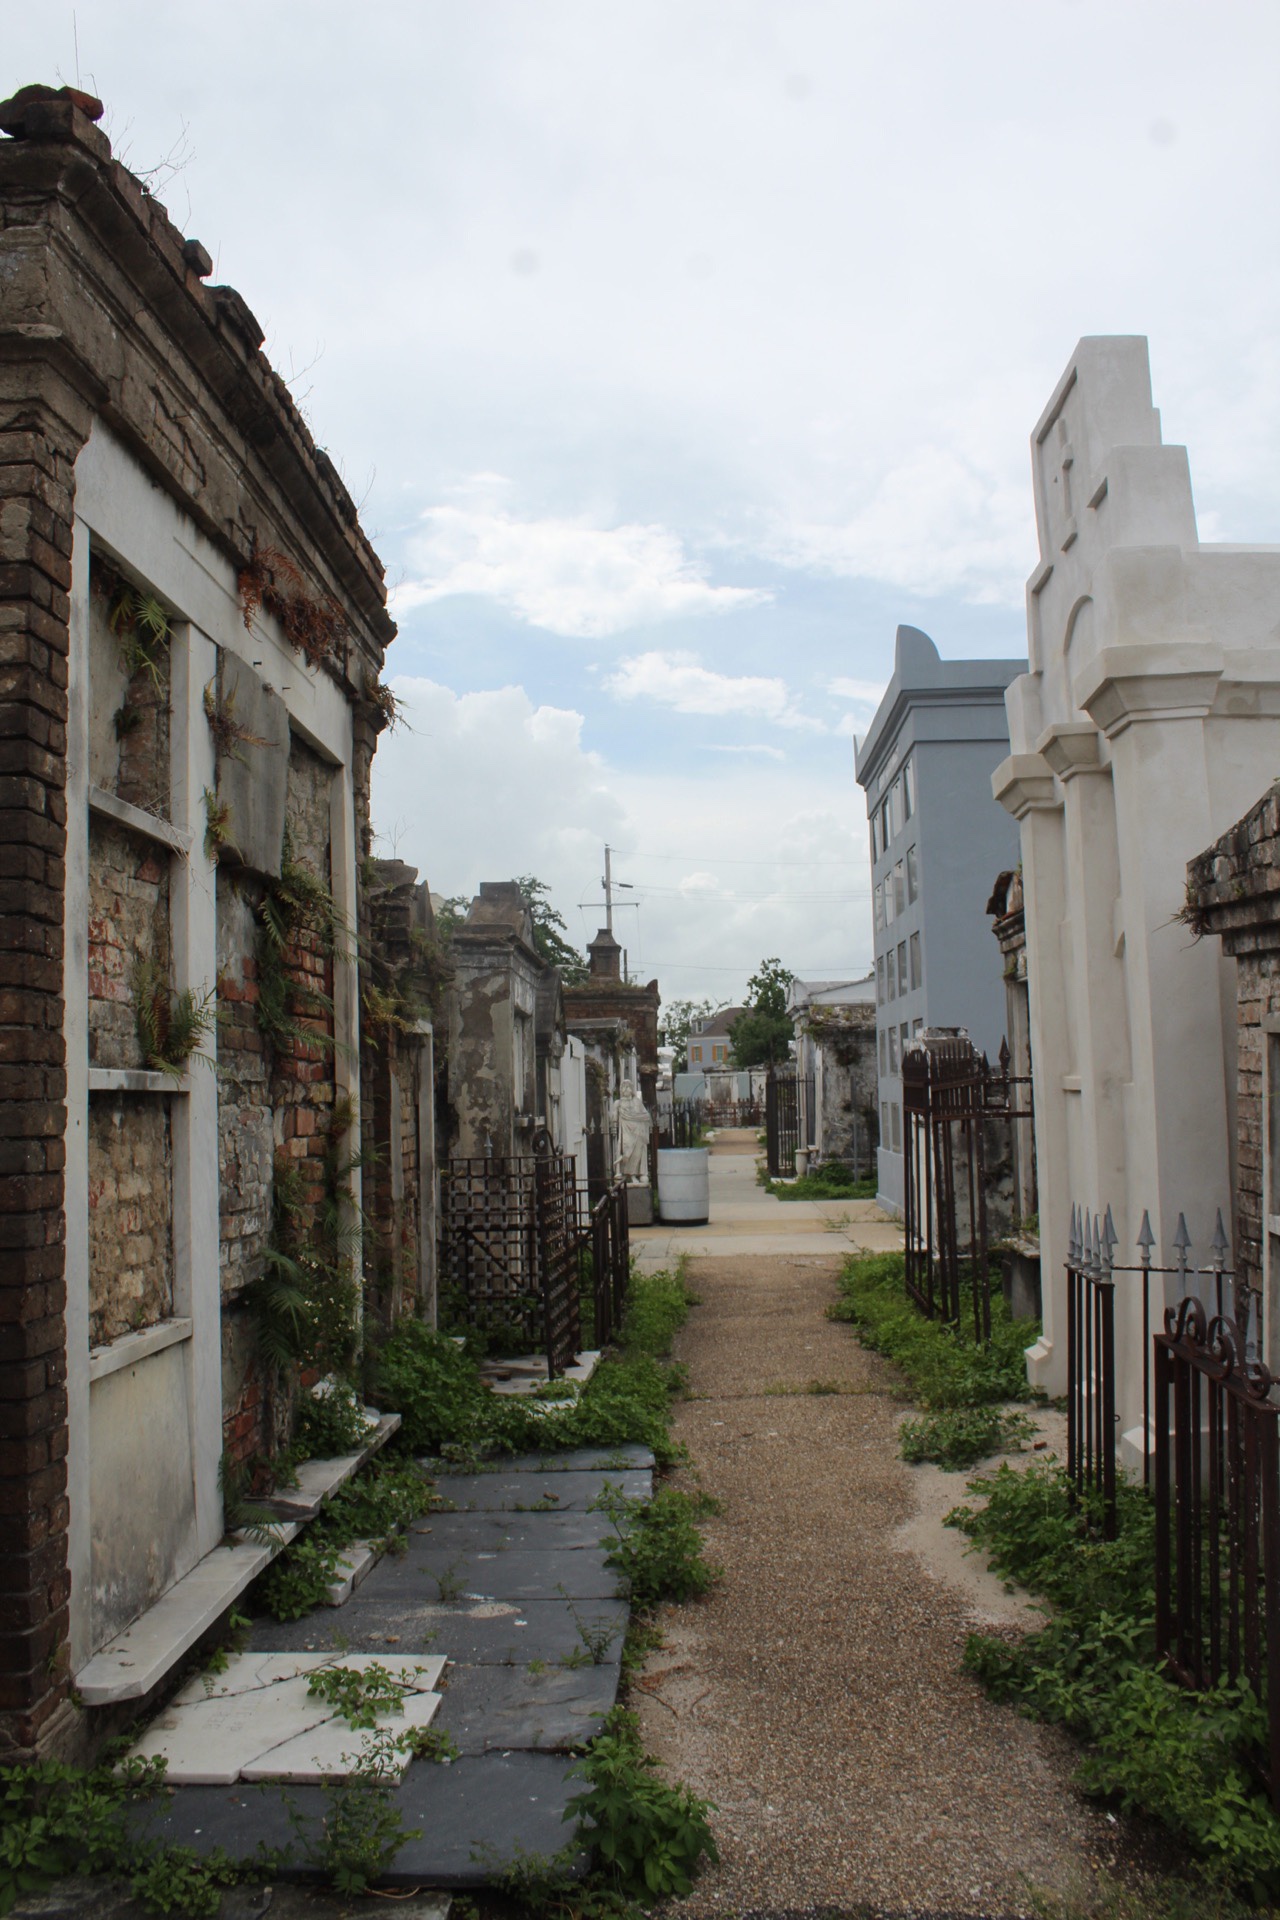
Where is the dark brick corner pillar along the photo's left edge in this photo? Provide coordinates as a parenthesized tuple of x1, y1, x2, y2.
(0, 318, 88, 1749)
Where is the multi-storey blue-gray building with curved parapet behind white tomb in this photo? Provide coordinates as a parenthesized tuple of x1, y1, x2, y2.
(856, 626, 1027, 1213)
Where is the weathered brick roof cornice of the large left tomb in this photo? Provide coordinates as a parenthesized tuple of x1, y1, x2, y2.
(0, 86, 395, 680)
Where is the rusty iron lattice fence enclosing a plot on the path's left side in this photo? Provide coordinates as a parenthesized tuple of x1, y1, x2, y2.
(441, 1154, 581, 1379)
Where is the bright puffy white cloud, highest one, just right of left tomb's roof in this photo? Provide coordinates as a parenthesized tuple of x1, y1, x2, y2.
(391, 474, 771, 639)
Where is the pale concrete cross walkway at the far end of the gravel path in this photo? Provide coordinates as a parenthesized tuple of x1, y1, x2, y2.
(631, 1127, 902, 1273)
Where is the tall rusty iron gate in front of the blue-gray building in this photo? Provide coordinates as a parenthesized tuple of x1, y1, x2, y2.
(902, 1029, 1031, 1340)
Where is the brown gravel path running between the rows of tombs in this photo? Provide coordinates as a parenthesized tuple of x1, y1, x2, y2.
(633, 1256, 1121, 1914)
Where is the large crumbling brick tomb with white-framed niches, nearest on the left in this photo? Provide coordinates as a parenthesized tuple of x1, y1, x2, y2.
(0, 88, 416, 1749)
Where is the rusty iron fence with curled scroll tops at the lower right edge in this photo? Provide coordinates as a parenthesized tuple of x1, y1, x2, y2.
(1153, 1298, 1280, 1811)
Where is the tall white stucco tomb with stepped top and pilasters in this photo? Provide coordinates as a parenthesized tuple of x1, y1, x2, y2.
(992, 338, 1280, 1457)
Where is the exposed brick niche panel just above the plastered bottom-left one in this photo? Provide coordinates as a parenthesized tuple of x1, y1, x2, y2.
(88, 1094, 173, 1346)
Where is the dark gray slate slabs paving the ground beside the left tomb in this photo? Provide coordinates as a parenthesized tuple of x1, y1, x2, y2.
(132, 1448, 652, 1887)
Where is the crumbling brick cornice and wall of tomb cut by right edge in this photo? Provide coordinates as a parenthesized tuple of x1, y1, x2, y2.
(1184, 783, 1280, 1286)
